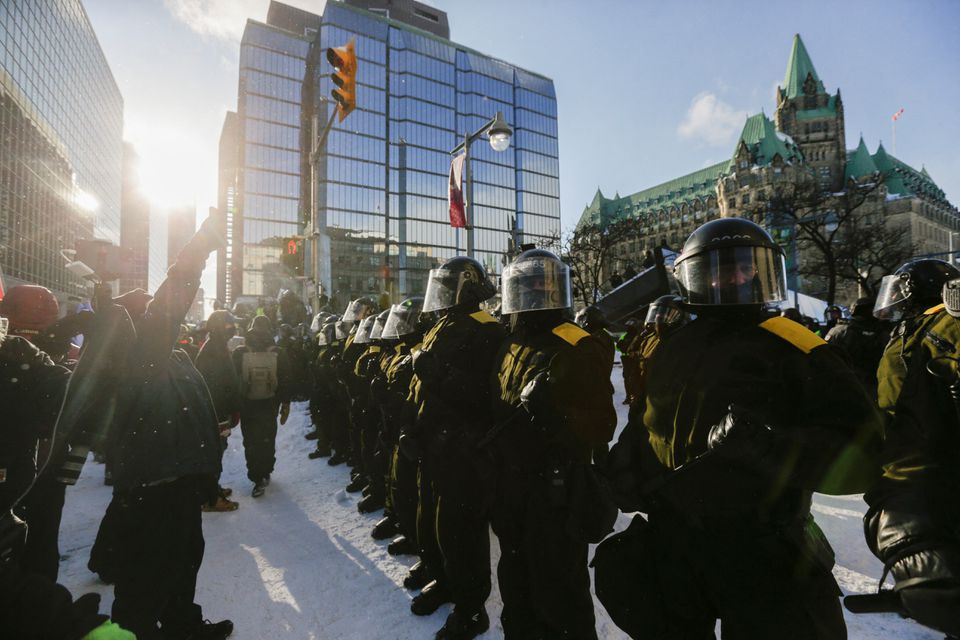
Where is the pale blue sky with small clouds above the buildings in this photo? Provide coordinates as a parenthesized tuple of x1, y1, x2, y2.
(84, 0, 960, 235)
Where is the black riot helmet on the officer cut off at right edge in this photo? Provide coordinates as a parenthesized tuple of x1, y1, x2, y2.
(873, 258, 960, 321)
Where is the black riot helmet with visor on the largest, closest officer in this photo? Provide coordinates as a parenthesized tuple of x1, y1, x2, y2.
(674, 218, 787, 308)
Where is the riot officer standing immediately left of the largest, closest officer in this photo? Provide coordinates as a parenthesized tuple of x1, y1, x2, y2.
(487, 249, 617, 640)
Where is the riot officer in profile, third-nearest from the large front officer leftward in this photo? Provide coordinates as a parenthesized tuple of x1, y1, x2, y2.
(410, 256, 503, 640)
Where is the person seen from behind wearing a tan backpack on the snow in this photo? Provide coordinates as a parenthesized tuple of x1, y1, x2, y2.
(233, 316, 291, 498)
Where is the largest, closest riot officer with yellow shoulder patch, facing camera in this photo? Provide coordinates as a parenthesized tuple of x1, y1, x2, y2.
(594, 218, 881, 640)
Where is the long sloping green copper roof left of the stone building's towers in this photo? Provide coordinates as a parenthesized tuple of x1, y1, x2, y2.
(577, 160, 729, 227)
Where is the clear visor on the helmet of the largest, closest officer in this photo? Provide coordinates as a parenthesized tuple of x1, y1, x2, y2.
(675, 247, 787, 305)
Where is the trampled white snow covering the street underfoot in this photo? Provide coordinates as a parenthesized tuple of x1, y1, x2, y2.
(60, 367, 943, 640)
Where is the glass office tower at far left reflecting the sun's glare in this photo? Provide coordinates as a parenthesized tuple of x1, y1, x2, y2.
(0, 0, 123, 297)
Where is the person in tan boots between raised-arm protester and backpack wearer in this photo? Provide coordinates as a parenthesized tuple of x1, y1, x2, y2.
(196, 309, 241, 511)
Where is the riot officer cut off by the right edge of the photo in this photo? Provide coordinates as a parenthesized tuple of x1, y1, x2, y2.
(864, 259, 960, 637)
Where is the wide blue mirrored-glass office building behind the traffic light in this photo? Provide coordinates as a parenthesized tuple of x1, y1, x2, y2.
(234, 0, 560, 305)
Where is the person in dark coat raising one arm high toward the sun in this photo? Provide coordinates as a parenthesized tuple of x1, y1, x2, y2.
(91, 218, 233, 640)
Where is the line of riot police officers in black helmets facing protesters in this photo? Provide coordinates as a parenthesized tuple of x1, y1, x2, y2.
(308, 218, 960, 640)
